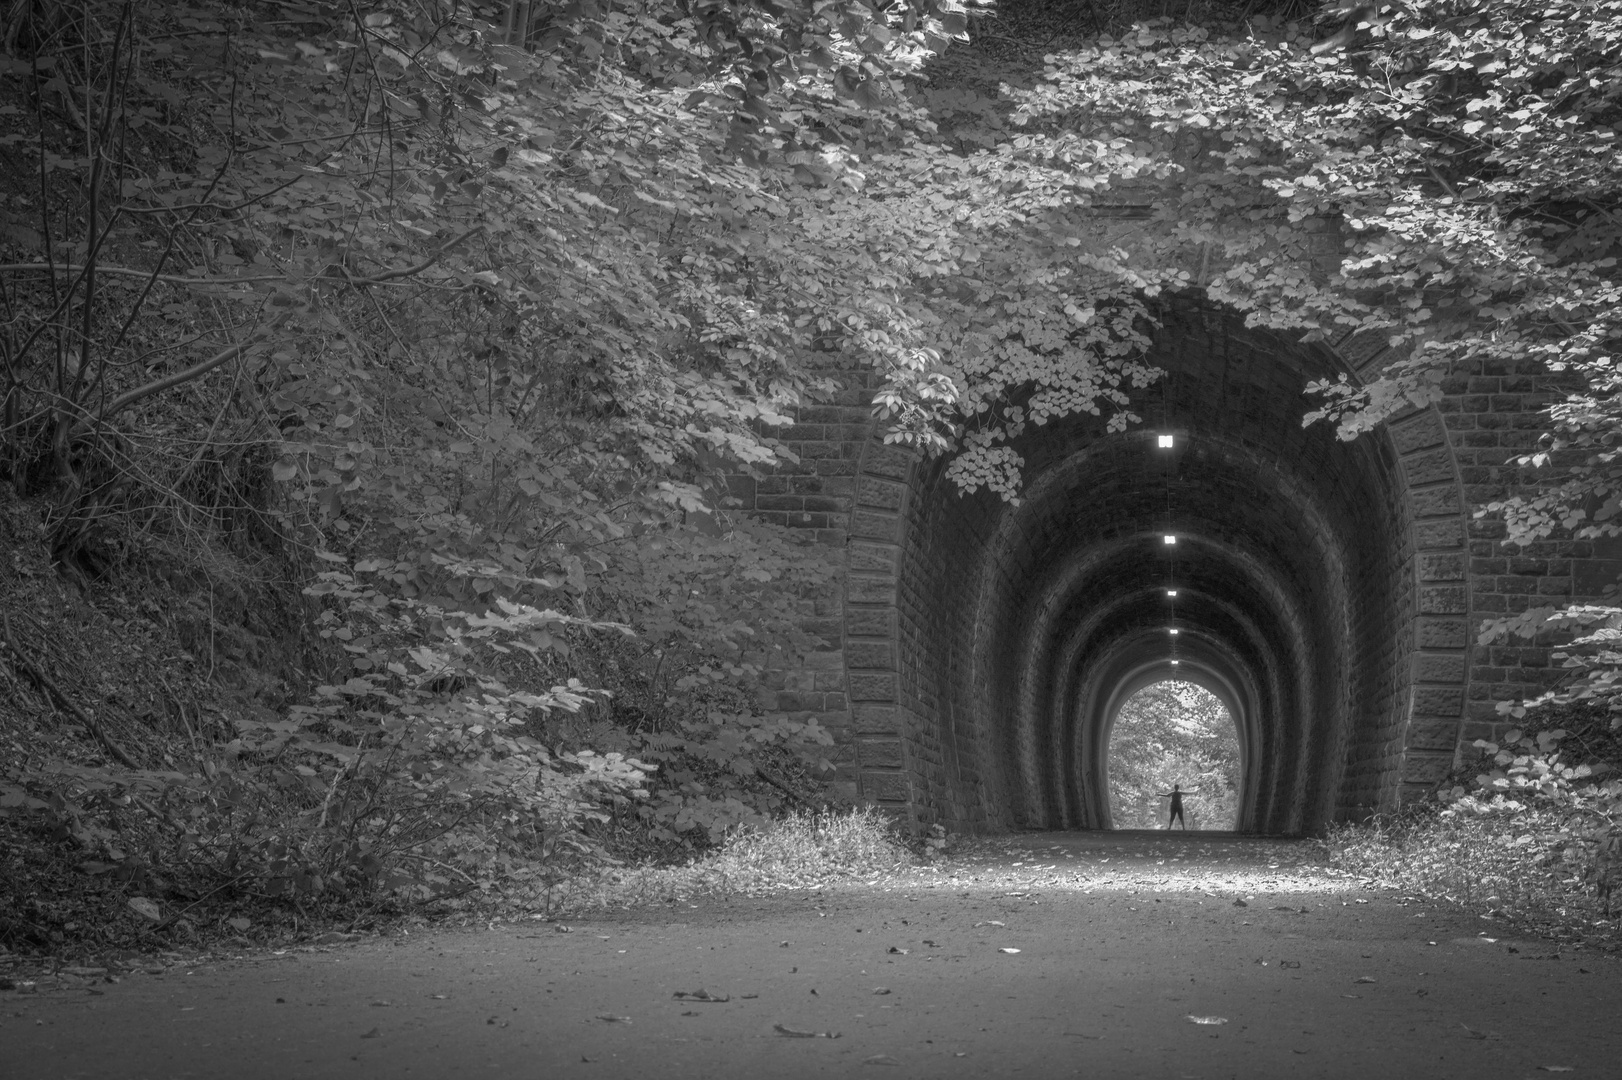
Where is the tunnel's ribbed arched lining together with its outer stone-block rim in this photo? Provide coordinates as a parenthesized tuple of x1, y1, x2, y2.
(830, 305, 1471, 832)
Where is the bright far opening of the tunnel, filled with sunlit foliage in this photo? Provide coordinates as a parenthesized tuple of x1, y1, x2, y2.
(1106, 679, 1242, 832)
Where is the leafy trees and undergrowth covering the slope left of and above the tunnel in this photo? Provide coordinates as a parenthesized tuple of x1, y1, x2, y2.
(0, 0, 1622, 949)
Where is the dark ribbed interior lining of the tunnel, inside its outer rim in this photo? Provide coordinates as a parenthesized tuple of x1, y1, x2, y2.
(897, 303, 1414, 835)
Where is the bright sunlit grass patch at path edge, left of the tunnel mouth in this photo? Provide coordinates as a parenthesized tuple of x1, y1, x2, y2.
(551, 808, 916, 911)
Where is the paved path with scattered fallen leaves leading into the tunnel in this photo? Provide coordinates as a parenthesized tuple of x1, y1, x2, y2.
(0, 834, 1622, 1080)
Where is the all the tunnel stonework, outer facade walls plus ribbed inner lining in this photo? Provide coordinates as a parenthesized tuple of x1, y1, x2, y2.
(732, 295, 1622, 834)
